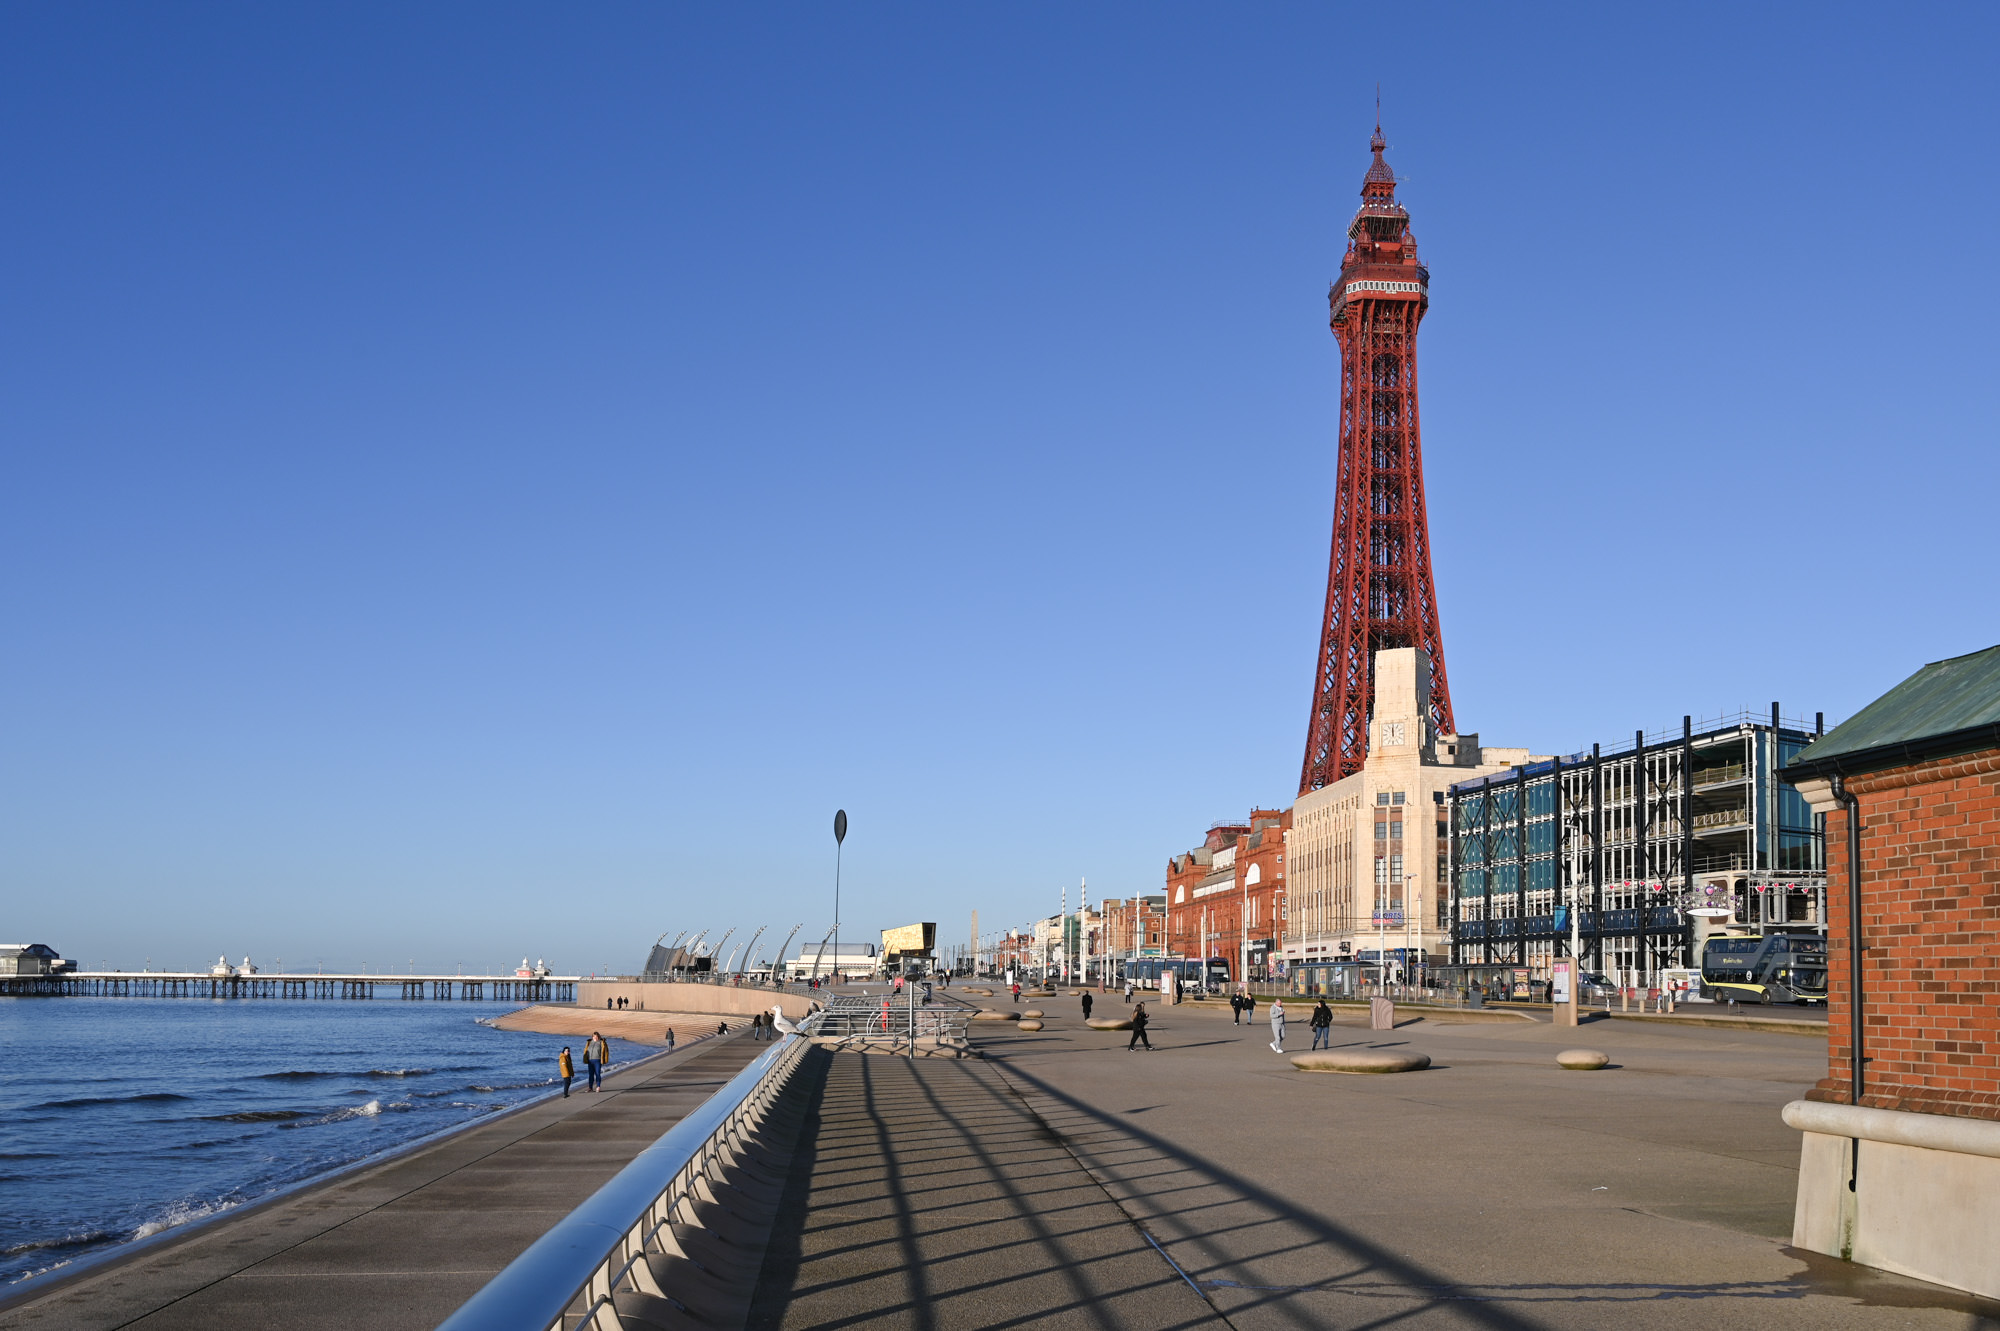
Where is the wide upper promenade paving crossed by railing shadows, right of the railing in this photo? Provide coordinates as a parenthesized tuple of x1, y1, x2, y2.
(752, 995, 2000, 1331)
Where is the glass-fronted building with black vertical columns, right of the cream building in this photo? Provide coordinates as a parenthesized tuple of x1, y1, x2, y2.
(1446, 707, 1826, 985)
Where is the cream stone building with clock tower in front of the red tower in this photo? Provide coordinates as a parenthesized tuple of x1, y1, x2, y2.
(1284, 648, 1540, 969)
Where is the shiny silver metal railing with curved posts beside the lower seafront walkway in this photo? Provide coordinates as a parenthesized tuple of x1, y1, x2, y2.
(438, 1013, 824, 1331)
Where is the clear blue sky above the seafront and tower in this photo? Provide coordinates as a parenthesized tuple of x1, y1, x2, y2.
(0, 4, 2000, 969)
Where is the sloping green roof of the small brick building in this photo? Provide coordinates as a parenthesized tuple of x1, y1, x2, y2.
(1784, 646, 2000, 777)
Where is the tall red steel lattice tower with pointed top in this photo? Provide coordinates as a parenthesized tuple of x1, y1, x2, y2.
(1298, 124, 1454, 793)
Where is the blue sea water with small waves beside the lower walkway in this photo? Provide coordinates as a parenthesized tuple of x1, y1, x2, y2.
(0, 997, 654, 1283)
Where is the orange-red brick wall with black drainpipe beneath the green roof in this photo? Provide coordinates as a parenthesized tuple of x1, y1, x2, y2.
(1810, 749, 2000, 1119)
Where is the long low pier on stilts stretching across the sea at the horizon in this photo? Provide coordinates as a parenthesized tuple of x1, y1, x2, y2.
(0, 971, 582, 1003)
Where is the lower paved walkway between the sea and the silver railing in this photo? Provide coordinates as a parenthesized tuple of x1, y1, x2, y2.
(0, 1035, 770, 1331)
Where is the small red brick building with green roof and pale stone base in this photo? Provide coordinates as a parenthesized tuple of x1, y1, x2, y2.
(1784, 648, 2000, 1297)
